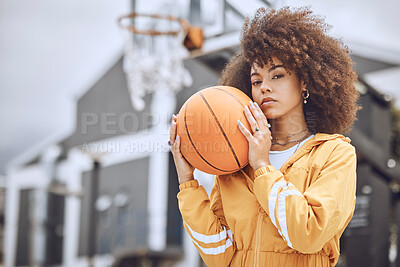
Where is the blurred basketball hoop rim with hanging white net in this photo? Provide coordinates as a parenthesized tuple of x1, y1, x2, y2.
(118, 13, 192, 111)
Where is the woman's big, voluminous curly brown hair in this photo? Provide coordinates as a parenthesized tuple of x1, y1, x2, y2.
(219, 6, 360, 133)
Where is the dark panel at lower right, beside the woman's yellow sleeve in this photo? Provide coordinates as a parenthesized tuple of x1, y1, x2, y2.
(340, 164, 391, 267)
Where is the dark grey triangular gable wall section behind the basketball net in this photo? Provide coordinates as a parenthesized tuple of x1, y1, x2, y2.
(62, 60, 152, 150)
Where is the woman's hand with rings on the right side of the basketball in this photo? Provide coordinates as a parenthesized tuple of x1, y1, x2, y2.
(238, 101, 271, 170)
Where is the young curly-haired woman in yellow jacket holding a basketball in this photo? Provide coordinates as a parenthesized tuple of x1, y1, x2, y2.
(170, 7, 359, 267)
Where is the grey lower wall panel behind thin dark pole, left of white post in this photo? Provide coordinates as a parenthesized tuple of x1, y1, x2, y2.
(79, 158, 149, 255)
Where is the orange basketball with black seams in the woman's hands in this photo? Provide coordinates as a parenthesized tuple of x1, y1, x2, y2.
(177, 86, 250, 175)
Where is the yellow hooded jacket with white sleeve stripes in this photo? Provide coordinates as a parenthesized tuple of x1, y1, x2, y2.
(178, 133, 357, 267)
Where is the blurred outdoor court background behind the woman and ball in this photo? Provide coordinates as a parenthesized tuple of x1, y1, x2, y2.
(0, 0, 400, 267)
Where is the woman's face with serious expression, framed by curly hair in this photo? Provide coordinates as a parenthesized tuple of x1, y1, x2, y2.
(250, 57, 305, 119)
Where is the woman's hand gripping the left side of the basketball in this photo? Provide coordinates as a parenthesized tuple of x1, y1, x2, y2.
(169, 115, 194, 184)
